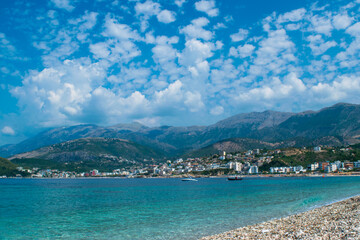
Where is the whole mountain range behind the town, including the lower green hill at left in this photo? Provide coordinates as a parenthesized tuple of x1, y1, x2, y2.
(0, 103, 360, 164)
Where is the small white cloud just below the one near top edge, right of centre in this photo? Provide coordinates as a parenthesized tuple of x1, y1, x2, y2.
(180, 17, 213, 41)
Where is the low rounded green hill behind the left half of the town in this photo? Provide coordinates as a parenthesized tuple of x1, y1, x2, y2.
(10, 138, 163, 169)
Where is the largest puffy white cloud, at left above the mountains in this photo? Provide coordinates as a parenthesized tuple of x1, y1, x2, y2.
(11, 61, 105, 126)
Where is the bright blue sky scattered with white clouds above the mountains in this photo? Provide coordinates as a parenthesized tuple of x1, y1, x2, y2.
(0, 0, 360, 145)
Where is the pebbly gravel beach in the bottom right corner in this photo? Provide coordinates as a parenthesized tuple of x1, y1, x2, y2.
(201, 196, 360, 240)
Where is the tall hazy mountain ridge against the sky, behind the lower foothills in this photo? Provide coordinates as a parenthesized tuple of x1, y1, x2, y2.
(0, 103, 360, 157)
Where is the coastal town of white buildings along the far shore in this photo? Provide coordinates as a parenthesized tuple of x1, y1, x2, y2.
(5, 146, 360, 178)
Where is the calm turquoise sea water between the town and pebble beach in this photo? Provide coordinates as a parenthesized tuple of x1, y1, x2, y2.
(0, 177, 360, 240)
